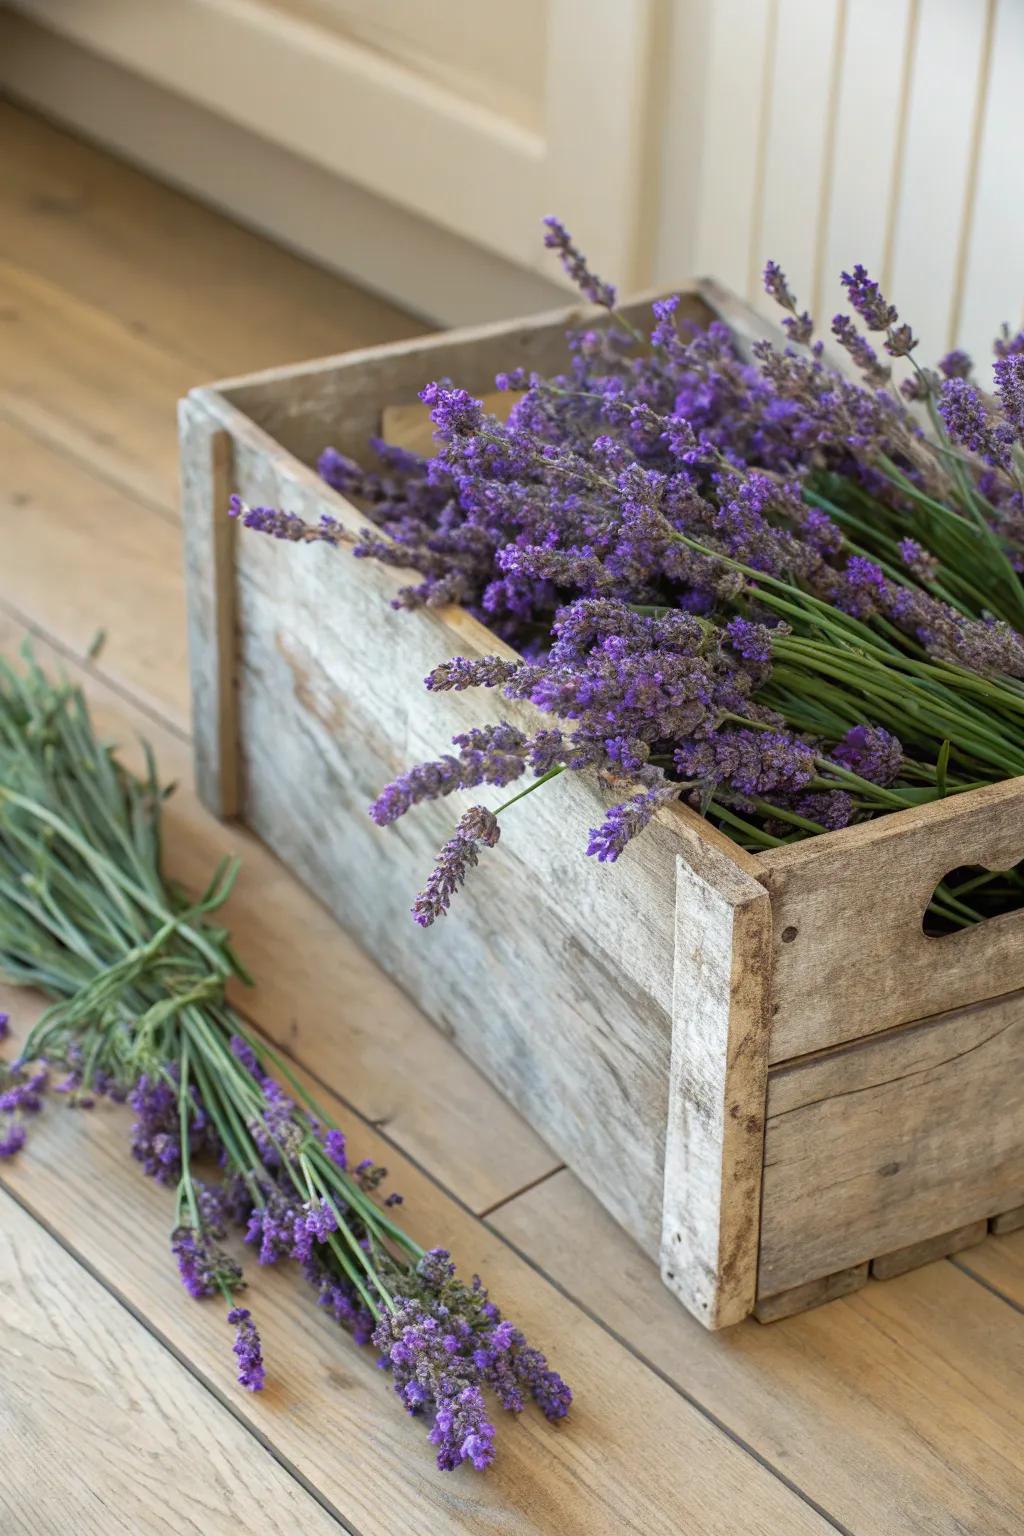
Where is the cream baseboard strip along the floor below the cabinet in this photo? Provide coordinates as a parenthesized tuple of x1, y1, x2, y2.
(0, 9, 565, 326)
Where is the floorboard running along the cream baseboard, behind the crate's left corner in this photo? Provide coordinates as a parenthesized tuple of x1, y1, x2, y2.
(0, 101, 422, 378)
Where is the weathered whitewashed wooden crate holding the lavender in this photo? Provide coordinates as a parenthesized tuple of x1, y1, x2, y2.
(181, 293, 1024, 1327)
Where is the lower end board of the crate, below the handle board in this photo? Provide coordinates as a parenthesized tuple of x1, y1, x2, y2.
(758, 992, 1024, 1295)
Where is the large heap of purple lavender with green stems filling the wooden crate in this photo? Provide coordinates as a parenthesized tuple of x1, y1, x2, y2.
(233, 220, 1024, 931)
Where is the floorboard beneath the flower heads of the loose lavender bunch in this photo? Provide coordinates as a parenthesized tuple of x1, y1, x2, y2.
(0, 1007, 831, 1536)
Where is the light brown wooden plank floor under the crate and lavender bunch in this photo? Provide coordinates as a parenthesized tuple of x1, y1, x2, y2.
(0, 104, 1024, 1536)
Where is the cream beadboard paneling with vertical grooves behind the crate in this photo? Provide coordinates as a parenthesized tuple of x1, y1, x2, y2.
(666, 0, 1024, 362)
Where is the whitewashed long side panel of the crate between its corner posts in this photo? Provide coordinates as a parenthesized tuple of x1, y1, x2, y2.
(225, 462, 680, 1252)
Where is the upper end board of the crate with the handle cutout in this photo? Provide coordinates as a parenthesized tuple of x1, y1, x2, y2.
(761, 779, 1024, 1062)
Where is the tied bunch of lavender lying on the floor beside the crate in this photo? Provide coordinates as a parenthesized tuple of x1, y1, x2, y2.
(0, 662, 571, 1470)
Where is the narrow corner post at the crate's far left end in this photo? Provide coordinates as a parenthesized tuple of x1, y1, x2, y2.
(178, 389, 239, 819)
